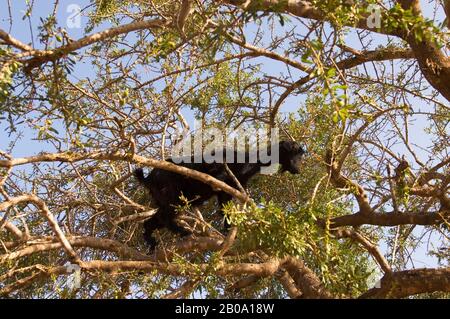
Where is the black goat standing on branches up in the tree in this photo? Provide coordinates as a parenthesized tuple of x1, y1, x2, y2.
(134, 141, 305, 249)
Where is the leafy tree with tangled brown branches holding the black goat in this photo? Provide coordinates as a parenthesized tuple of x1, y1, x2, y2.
(0, 0, 450, 298)
